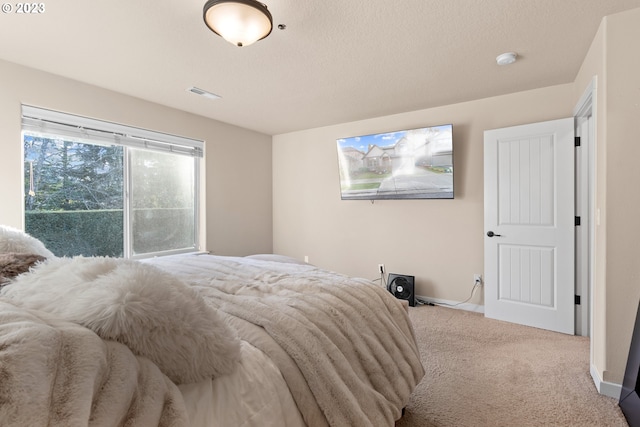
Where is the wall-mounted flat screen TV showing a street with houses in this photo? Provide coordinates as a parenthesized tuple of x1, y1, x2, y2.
(336, 124, 453, 200)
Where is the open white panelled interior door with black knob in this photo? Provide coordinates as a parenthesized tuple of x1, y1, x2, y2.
(484, 118, 575, 334)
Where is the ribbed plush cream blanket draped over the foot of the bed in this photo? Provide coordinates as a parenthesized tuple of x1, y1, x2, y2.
(148, 255, 424, 426)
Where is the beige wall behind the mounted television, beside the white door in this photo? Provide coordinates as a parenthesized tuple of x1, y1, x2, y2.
(273, 84, 575, 305)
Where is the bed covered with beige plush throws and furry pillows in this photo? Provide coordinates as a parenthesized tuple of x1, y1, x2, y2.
(0, 226, 424, 427)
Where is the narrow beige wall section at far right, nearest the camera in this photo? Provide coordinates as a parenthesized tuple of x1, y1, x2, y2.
(603, 9, 640, 383)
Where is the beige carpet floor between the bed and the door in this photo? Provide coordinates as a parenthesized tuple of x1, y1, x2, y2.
(396, 306, 627, 427)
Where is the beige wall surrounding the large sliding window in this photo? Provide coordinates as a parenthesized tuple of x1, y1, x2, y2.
(0, 61, 272, 255)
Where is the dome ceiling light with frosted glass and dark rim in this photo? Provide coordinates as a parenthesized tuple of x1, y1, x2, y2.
(202, 0, 273, 46)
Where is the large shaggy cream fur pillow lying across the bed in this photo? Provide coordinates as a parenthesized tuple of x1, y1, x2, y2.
(0, 257, 240, 384)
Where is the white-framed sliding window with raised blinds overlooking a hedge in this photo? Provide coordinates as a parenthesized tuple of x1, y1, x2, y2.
(22, 106, 203, 258)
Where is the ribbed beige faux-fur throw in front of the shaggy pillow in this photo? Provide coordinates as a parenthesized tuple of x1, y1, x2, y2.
(0, 300, 189, 427)
